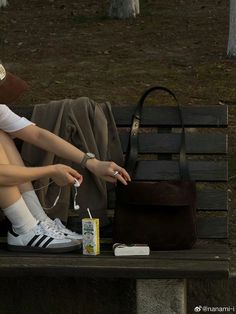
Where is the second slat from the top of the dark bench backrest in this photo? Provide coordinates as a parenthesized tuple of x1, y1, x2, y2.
(120, 133, 227, 154)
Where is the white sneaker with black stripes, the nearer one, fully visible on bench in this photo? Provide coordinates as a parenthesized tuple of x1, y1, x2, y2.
(7, 221, 81, 253)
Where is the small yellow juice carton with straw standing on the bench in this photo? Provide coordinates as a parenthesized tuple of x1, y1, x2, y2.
(82, 218, 100, 255)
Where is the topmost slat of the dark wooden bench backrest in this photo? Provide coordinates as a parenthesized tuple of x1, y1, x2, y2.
(112, 105, 228, 127)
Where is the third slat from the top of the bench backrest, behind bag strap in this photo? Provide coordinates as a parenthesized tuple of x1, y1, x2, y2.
(135, 160, 228, 182)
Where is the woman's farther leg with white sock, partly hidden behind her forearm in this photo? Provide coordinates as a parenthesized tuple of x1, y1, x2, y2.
(0, 131, 48, 221)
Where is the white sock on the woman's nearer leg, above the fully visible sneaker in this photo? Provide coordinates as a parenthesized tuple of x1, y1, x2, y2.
(3, 197, 37, 234)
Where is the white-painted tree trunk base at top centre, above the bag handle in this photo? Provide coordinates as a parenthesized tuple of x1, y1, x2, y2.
(109, 0, 139, 19)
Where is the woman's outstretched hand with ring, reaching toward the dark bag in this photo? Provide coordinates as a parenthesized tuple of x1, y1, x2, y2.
(86, 159, 131, 185)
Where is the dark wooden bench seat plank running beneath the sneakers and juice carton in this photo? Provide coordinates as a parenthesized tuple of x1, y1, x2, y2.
(0, 252, 229, 279)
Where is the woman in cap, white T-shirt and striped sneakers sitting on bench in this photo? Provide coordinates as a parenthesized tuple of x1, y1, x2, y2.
(0, 65, 130, 252)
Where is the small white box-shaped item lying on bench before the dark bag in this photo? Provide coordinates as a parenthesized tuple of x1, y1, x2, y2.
(113, 243, 150, 256)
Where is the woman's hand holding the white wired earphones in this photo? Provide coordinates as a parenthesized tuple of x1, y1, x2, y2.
(51, 164, 83, 186)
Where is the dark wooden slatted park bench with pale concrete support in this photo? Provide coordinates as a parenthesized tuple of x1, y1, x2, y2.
(0, 105, 229, 314)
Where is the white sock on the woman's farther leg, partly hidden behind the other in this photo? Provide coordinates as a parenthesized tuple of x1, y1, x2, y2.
(22, 190, 49, 221)
